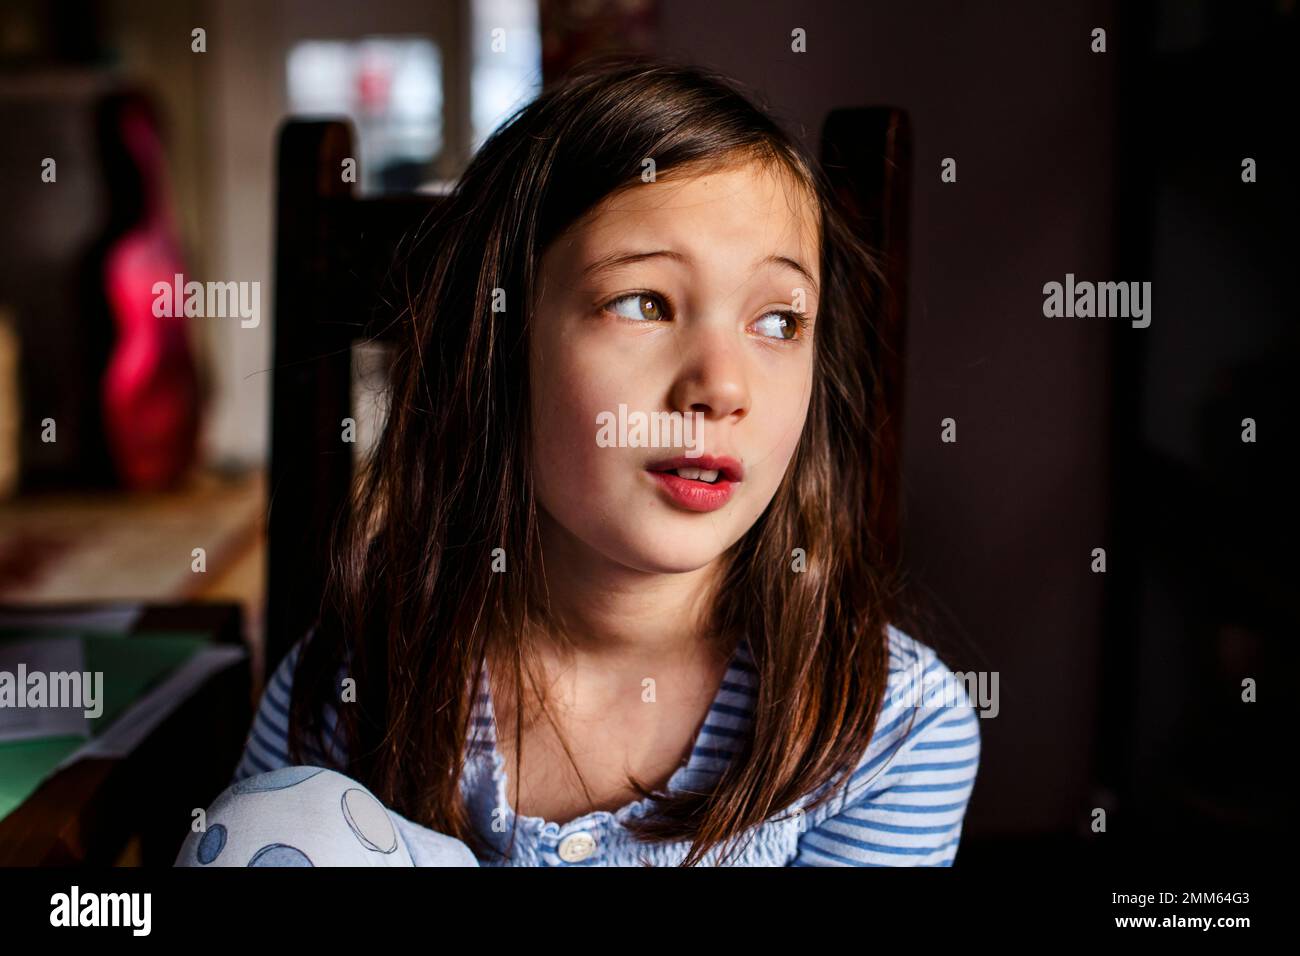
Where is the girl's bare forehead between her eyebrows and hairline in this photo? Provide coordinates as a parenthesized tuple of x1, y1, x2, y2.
(551, 161, 820, 276)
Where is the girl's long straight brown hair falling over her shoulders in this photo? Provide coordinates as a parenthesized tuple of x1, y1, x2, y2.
(290, 56, 897, 866)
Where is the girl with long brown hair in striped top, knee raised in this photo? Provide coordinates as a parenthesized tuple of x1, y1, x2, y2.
(178, 59, 979, 866)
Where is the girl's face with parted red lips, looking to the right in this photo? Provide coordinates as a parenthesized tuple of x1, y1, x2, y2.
(530, 163, 820, 574)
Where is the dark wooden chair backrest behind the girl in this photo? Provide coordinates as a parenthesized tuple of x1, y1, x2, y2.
(264, 107, 910, 675)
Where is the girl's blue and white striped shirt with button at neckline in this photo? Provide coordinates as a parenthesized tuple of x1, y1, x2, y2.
(235, 626, 980, 866)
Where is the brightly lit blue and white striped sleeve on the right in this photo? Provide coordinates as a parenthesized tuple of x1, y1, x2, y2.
(790, 633, 980, 866)
